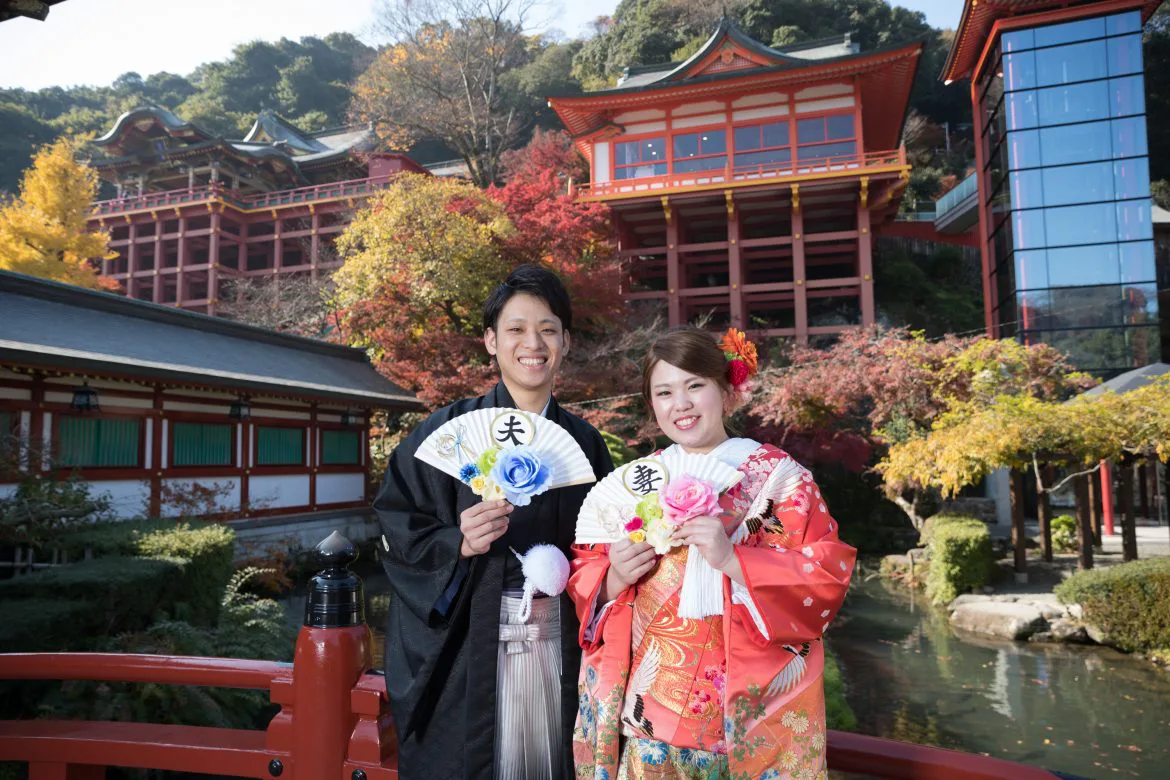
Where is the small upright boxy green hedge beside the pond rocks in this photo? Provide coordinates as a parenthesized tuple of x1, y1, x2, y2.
(922, 515, 995, 603)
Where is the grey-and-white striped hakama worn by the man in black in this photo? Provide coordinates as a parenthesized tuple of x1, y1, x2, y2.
(496, 591, 564, 780)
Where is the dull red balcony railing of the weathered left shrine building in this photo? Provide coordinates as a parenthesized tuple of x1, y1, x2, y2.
(94, 175, 394, 216)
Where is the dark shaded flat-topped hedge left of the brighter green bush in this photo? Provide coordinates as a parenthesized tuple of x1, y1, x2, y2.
(0, 557, 188, 633)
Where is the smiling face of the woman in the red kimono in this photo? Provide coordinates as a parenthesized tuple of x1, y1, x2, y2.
(651, 360, 728, 453)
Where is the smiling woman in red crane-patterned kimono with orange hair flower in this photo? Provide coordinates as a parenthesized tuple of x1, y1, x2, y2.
(569, 327, 856, 780)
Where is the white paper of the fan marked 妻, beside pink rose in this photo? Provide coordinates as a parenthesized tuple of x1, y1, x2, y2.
(574, 448, 743, 548)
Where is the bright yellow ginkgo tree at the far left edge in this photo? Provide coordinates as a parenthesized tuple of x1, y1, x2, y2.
(0, 138, 117, 289)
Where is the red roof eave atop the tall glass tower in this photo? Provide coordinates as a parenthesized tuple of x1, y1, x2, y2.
(940, 0, 1162, 84)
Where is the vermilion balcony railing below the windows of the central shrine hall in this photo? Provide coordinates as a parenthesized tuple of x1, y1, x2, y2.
(577, 147, 907, 200)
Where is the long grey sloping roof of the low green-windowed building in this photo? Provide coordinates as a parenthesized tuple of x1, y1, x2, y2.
(0, 271, 419, 408)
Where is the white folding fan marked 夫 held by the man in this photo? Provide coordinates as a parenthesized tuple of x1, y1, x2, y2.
(414, 407, 597, 506)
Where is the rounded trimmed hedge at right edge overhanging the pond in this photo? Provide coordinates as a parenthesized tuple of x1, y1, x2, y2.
(1057, 558, 1170, 653)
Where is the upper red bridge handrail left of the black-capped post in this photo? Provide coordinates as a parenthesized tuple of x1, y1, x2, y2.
(0, 653, 293, 690)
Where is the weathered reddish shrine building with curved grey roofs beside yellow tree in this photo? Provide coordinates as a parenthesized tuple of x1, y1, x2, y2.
(90, 108, 425, 315)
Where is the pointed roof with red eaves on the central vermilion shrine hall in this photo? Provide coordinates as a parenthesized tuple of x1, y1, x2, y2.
(548, 18, 924, 150)
